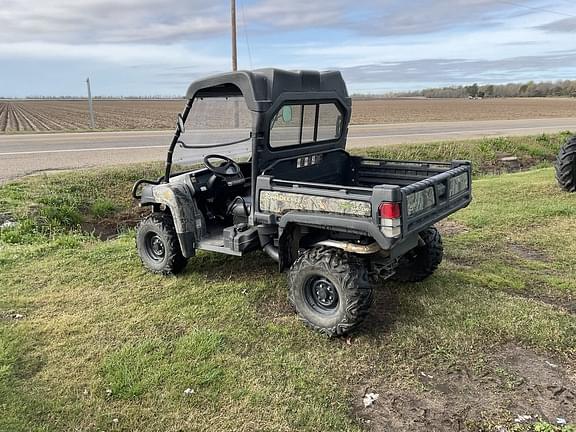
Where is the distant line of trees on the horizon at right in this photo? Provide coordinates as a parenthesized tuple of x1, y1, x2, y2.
(395, 80, 576, 98)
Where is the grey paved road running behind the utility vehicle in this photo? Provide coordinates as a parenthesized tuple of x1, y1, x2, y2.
(0, 118, 576, 182)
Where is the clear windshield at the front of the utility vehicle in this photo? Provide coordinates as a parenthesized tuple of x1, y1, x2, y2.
(173, 97, 252, 166)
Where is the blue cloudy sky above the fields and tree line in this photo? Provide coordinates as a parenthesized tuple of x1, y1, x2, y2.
(0, 0, 576, 97)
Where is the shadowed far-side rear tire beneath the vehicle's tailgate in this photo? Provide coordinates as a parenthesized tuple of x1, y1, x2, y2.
(393, 227, 444, 282)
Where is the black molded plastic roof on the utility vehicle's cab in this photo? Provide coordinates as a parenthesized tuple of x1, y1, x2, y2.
(186, 69, 351, 111)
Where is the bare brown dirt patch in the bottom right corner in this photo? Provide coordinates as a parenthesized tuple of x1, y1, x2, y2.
(353, 345, 576, 432)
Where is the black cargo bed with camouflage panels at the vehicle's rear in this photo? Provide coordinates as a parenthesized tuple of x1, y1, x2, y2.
(256, 152, 472, 247)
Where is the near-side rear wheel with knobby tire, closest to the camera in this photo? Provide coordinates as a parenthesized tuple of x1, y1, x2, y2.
(288, 247, 372, 337)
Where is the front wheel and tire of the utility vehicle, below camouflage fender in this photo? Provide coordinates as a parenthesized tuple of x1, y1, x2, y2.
(136, 212, 187, 275)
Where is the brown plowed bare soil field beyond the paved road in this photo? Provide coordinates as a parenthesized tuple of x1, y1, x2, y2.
(0, 98, 576, 133)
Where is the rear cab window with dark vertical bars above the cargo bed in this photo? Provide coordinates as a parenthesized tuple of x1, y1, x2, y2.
(270, 103, 343, 148)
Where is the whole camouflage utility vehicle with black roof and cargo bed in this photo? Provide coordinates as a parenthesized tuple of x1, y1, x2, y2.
(133, 69, 471, 336)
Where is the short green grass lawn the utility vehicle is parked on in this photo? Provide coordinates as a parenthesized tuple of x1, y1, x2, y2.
(0, 133, 576, 431)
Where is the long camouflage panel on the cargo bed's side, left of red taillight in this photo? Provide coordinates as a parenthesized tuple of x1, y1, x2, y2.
(260, 191, 372, 217)
